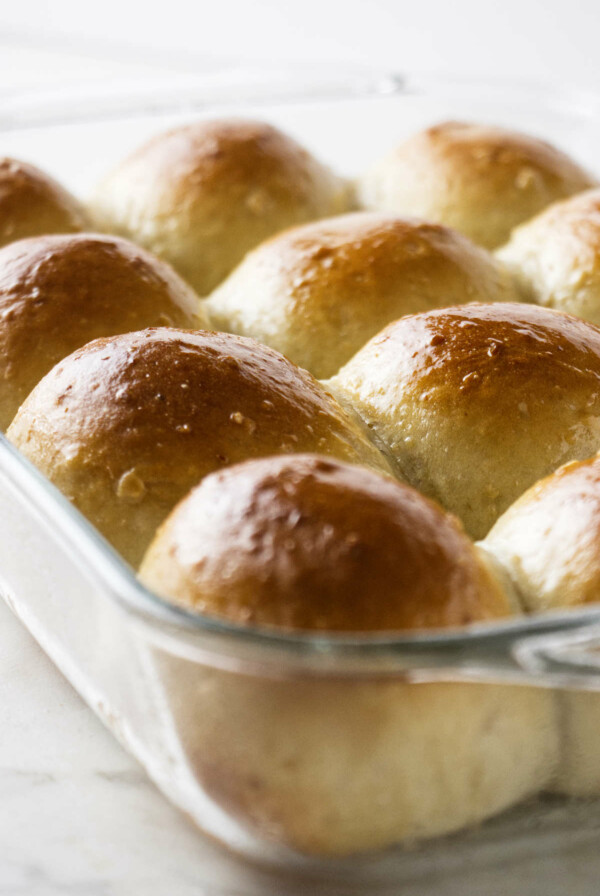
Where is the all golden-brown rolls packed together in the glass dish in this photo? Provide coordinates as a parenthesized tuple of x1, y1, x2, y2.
(0, 120, 600, 856)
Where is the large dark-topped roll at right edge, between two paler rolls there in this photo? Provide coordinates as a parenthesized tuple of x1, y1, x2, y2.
(329, 303, 600, 538)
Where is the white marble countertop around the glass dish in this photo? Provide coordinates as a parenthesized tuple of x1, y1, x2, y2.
(0, 24, 600, 896)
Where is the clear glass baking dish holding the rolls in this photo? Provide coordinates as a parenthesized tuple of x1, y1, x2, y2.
(0, 70, 600, 893)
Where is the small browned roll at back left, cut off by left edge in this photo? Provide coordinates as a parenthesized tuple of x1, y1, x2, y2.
(0, 158, 87, 246)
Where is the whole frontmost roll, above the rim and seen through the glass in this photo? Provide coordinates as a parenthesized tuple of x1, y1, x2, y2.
(140, 456, 556, 855)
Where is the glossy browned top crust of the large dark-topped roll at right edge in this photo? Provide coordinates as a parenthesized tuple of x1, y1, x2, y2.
(344, 302, 600, 412)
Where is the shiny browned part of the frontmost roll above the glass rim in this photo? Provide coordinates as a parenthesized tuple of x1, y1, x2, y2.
(141, 455, 510, 631)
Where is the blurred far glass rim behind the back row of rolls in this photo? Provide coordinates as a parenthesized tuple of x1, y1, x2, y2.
(0, 64, 600, 133)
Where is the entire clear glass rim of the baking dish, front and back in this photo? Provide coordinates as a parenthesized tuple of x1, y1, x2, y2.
(0, 67, 600, 675)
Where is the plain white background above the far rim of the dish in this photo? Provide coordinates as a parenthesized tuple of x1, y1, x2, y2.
(0, 0, 600, 85)
